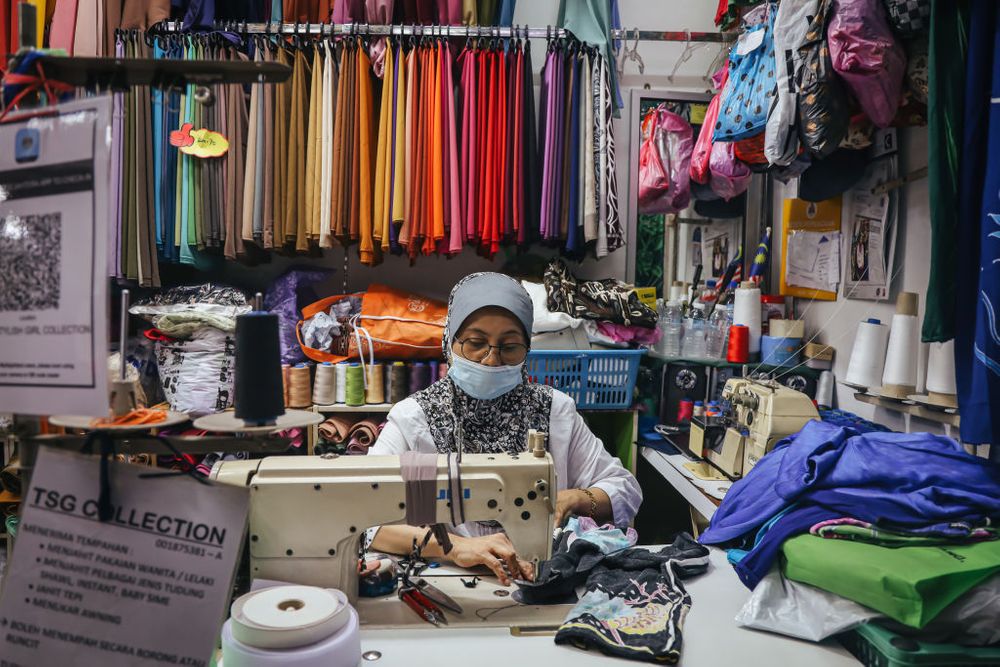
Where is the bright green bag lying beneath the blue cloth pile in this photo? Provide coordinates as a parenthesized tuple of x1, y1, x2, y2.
(781, 535, 1000, 628)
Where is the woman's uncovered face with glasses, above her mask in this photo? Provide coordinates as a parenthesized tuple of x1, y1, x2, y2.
(451, 306, 528, 366)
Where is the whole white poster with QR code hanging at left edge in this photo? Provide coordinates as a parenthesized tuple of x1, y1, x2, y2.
(0, 98, 111, 416)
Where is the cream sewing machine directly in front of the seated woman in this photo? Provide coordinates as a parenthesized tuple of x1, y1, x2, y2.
(211, 433, 558, 603)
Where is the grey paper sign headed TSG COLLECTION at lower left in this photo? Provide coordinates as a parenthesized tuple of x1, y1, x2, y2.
(0, 448, 249, 667)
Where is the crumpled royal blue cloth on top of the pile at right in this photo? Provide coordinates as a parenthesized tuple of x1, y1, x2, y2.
(701, 421, 1000, 544)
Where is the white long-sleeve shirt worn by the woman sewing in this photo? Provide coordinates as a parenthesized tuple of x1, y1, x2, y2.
(369, 391, 642, 536)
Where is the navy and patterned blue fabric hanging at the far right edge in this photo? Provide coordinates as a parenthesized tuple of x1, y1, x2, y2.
(955, 0, 1000, 460)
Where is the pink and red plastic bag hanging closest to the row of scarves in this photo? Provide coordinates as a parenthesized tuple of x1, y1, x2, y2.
(639, 106, 694, 213)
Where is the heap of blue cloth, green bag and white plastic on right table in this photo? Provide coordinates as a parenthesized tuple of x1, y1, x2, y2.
(701, 422, 1000, 646)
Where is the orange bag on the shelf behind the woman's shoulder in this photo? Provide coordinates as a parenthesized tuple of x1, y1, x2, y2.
(295, 284, 448, 363)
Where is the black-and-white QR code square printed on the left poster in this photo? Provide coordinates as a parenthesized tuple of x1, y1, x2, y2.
(0, 213, 62, 311)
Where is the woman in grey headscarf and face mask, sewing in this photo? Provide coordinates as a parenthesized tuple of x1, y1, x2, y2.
(369, 273, 642, 586)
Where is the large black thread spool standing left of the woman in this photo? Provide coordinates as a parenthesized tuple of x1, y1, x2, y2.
(235, 311, 285, 426)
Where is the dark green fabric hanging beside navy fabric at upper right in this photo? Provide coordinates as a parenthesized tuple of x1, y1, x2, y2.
(921, 0, 968, 343)
